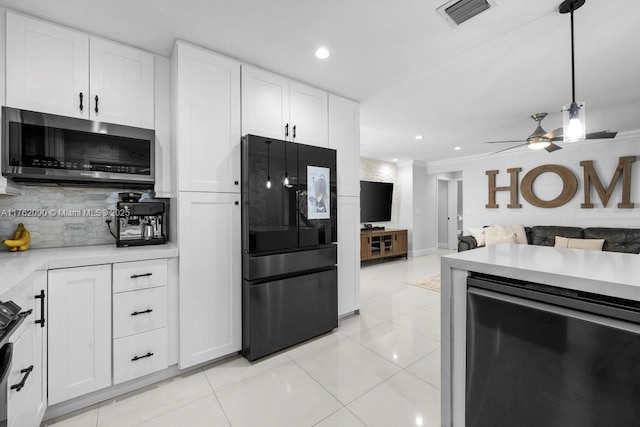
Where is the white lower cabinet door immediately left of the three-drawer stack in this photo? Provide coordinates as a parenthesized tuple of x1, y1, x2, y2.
(48, 264, 111, 405)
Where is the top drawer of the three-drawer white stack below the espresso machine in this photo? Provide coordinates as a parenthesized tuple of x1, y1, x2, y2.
(113, 259, 167, 293)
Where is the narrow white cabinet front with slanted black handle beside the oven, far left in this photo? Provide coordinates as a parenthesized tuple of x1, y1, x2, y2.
(6, 324, 37, 420)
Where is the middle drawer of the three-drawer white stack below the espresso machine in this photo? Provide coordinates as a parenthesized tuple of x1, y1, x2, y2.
(113, 286, 167, 339)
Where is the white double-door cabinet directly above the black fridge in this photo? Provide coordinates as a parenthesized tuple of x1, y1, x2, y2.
(242, 65, 328, 147)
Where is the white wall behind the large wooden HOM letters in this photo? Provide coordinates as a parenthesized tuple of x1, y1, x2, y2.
(427, 135, 640, 234)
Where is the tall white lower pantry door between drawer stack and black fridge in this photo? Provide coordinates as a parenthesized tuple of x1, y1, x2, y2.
(178, 192, 242, 369)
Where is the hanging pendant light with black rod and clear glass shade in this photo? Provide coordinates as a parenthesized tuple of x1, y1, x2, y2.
(559, 0, 586, 142)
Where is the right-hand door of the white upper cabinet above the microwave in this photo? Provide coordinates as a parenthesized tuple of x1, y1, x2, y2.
(89, 37, 154, 129)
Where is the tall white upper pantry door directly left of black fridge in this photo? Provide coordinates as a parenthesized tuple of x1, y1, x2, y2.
(171, 42, 240, 193)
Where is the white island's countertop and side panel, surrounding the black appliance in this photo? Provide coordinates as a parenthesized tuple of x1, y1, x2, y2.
(441, 244, 640, 426)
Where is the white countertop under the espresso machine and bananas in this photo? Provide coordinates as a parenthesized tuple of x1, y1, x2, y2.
(0, 244, 178, 299)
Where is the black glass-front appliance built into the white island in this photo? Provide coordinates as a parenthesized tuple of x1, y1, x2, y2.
(465, 273, 640, 427)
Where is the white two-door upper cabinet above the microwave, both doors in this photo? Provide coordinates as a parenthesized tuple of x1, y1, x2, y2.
(6, 12, 154, 129)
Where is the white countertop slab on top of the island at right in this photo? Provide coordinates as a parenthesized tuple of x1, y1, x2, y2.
(442, 244, 640, 300)
